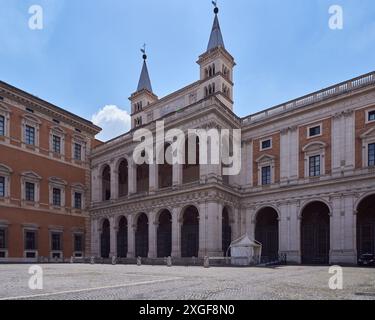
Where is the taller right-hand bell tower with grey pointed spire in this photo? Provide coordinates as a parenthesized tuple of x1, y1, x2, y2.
(197, 1, 236, 111)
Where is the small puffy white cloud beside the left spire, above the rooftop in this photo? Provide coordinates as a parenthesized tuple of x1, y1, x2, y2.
(91, 105, 131, 141)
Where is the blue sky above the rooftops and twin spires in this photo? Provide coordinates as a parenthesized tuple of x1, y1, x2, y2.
(0, 0, 375, 140)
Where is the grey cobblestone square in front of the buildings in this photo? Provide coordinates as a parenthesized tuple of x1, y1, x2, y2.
(0, 264, 375, 300)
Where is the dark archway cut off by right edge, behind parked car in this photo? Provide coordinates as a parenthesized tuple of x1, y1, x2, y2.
(357, 194, 375, 258)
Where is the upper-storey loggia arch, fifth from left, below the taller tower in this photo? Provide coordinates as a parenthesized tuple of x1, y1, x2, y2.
(183, 137, 200, 183)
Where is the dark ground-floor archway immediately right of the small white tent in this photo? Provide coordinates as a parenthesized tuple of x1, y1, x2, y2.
(255, 207, 279, 262)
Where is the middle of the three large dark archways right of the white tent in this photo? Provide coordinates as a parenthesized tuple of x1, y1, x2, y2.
(301, 201, 330, 264)
